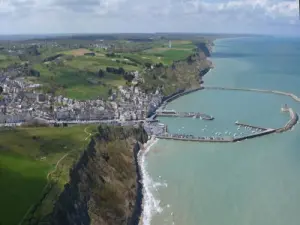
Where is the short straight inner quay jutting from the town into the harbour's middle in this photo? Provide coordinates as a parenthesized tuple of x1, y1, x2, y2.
(156, 110, 214, 120)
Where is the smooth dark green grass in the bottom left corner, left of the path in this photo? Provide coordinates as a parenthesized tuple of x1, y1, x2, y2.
(0, 153, 50, 225)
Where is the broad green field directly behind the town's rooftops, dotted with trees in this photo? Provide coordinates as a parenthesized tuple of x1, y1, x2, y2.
(29, 49, 142, 100)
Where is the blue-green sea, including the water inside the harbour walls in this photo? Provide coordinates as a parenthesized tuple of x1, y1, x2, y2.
(142, 37, 300, 225)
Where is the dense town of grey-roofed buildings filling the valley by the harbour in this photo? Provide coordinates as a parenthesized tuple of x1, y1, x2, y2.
(0, 73, 163, 125)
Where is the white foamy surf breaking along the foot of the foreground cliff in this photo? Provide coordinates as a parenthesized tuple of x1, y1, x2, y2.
(138, 138, 167, 225)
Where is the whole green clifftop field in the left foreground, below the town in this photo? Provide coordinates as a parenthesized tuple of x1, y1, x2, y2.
(0, 126, 95, 225)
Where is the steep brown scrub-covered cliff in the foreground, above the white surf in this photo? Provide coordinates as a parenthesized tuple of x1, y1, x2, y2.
(51, 126, 147, 225)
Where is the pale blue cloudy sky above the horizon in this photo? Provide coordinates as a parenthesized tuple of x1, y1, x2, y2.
(0, 0, 300, 36)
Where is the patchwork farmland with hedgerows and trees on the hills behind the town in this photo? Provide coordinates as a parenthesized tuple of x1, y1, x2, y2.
(0, 40, 196, 100)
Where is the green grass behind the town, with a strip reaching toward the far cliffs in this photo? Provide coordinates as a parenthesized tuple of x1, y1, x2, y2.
(34, 40, 195, 100)
